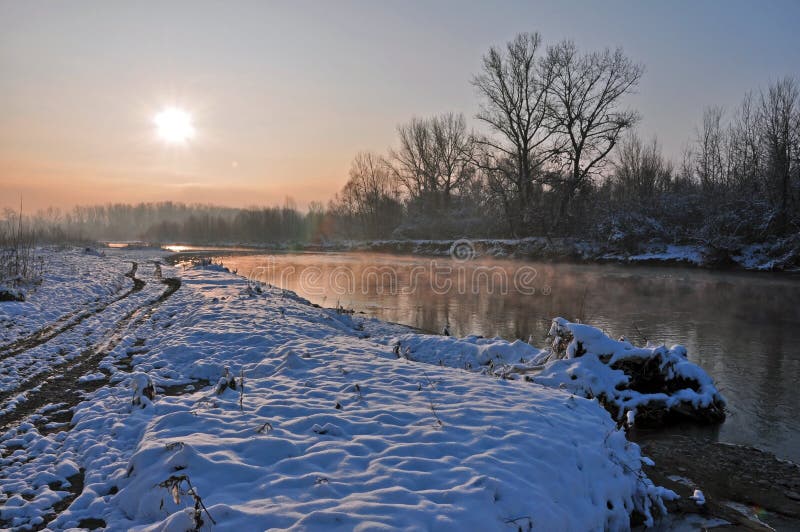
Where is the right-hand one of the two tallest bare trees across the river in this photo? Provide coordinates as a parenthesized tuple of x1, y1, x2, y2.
(546, 41, 644, 217)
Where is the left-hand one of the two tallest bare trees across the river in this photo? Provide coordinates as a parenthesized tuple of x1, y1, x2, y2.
(472, 33, 552, 232)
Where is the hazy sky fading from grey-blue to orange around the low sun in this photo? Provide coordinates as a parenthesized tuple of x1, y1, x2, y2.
(0, 0, 800, 211)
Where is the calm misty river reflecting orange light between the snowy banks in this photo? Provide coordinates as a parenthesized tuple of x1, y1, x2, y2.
(186, 252, 800, 463)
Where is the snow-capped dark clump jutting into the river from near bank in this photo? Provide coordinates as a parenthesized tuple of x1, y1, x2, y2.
(533, 318, 725, 425)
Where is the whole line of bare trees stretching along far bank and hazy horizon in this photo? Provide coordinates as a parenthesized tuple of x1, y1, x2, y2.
(6, 34, 800, 249)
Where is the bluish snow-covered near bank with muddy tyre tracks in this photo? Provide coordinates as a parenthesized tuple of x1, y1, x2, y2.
(0, 253, 720, 530)
